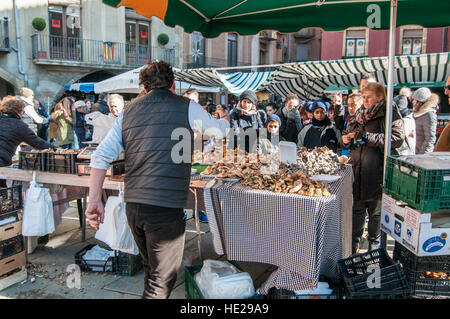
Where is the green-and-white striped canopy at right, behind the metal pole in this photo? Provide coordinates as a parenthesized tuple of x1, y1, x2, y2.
(261, 52, 450, 100)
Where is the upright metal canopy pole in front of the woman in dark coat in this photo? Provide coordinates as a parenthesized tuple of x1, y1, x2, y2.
(380, 0, 398, 249)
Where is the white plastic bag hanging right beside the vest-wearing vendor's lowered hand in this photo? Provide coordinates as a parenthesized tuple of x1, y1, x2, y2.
(95, 184, 139, 255)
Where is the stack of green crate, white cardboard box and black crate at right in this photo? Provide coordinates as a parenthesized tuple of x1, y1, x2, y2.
(381, 152, 450, 298)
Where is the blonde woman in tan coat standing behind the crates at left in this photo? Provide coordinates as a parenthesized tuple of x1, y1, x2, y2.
(51, 97, 76, 148)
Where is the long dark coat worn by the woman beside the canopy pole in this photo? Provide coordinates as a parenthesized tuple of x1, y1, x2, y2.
(347, 100, 405, 201)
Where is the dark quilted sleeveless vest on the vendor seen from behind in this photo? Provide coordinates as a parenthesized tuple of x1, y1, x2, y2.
(122, 89, 193, 208)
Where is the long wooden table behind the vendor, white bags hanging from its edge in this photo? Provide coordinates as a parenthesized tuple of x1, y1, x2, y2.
(0, 167, 209, 257)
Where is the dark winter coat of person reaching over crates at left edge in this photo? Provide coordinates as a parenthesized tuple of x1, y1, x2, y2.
(0, 114, 53, 167)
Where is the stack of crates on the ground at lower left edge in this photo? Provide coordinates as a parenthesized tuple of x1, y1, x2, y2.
(0, 185, 27, 290)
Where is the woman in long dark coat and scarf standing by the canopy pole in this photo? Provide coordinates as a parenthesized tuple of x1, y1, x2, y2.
(342, 83, 405, 253)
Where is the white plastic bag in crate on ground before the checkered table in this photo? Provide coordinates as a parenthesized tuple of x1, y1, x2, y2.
(194, 259, 255, 299)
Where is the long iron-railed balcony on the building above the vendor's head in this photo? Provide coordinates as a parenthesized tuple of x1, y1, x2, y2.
(31, 34, 175, 69)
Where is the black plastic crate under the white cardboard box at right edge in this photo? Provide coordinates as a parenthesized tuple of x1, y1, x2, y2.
(393, 242, 450, 297)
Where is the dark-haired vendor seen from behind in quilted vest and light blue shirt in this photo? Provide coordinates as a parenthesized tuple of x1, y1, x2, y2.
(86, 61, 229, 298)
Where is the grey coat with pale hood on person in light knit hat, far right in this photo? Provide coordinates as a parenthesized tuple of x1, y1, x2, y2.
(414, 93, 439, 154)
